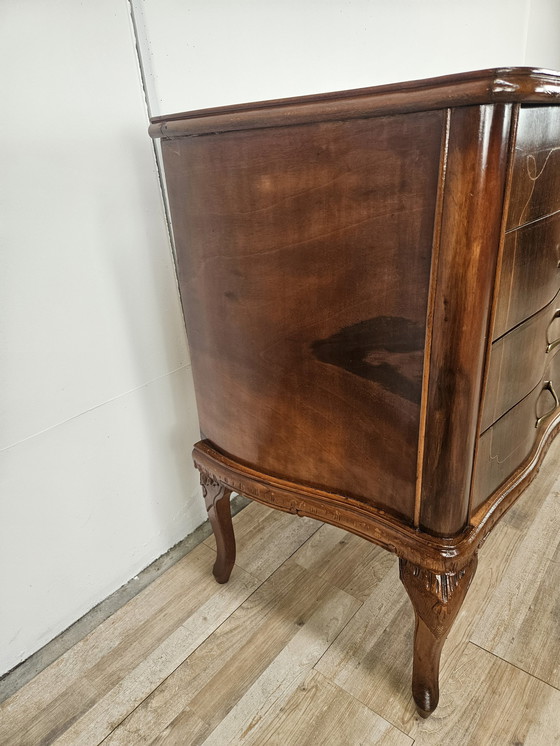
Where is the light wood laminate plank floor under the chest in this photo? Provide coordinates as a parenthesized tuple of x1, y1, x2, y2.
(0, 441, 560, 746)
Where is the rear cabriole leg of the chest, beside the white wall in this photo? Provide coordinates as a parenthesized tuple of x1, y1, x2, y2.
(200, 471, 235, 583)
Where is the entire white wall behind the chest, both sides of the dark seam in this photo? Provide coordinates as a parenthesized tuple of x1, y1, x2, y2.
(0, 0, 560, 673)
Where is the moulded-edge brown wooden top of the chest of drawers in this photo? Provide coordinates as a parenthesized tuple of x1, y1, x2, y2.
(149, 67, 560, 139)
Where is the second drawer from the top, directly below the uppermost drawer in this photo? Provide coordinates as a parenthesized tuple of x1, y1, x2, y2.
(493, 213, 560, 339)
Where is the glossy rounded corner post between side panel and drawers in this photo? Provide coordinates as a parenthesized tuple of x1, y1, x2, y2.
(420, 104, 511, 536)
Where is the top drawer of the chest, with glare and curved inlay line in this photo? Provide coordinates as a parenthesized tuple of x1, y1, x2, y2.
(507, 106, 560, 230)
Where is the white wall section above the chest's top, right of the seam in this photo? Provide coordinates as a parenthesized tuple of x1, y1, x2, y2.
(133, 0, 560, 115)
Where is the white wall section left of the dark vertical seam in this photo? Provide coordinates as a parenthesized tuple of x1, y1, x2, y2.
(0, 0, 205, 673)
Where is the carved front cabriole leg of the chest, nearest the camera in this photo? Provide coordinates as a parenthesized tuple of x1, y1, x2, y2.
(399, 554, 477, 717)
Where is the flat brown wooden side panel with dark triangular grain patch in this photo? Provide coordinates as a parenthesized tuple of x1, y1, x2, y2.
(162, 112, 444, 522)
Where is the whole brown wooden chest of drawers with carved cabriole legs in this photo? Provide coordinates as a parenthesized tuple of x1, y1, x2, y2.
(150, 68, 560, 716)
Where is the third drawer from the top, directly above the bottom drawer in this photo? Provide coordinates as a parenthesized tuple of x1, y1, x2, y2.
(480, 294, 560, 432)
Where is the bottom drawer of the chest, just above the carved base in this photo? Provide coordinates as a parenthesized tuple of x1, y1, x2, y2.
(472, 348, 560, 510)
